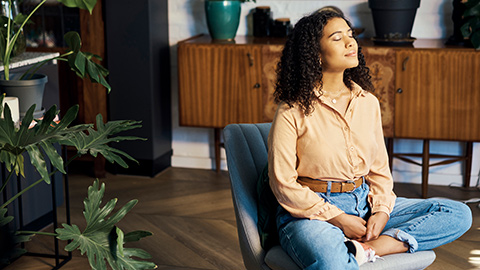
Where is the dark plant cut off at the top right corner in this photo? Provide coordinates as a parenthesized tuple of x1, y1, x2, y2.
(461, 0, 480, 50)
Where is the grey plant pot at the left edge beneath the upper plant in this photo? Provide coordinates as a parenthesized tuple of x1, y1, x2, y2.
(0, 73, 48, 118)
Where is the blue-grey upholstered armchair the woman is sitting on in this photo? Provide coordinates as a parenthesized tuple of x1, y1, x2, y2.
(224, 123, 435, 270)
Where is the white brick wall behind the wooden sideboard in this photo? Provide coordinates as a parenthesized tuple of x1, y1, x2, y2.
(168, 0, 480, 185)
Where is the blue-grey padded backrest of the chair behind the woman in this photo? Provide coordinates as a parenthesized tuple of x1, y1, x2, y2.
(223, 123, 271, 269)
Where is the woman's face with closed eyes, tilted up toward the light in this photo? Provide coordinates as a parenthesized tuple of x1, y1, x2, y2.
(320, 18, 358, 72)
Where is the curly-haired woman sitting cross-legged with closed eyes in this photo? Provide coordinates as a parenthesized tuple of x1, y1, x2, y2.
(268, 10, 472, 270)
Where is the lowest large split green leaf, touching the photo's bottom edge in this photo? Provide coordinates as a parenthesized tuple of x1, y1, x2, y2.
(56, 179, 157, 270)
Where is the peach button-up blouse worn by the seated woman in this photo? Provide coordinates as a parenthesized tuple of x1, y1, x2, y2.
(268, 84, 396, 220)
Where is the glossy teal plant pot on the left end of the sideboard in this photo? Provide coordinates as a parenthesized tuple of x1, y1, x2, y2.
(205, 0, 241, 40)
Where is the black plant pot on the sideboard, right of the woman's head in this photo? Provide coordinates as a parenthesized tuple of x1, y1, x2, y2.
(368, 0, 420, 42)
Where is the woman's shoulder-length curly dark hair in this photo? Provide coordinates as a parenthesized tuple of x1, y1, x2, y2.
(274, 10, 374, 115)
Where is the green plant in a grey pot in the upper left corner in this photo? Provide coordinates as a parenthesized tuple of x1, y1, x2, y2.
(0, 0, 111, 117)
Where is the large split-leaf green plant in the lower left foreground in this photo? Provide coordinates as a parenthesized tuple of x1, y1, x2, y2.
(0, 95, 156, 270)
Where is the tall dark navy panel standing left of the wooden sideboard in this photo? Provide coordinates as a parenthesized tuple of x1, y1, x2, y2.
(105, 0, 172, 176)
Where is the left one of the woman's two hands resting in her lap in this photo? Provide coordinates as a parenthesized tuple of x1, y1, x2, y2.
(328, 213, 367, 240)
